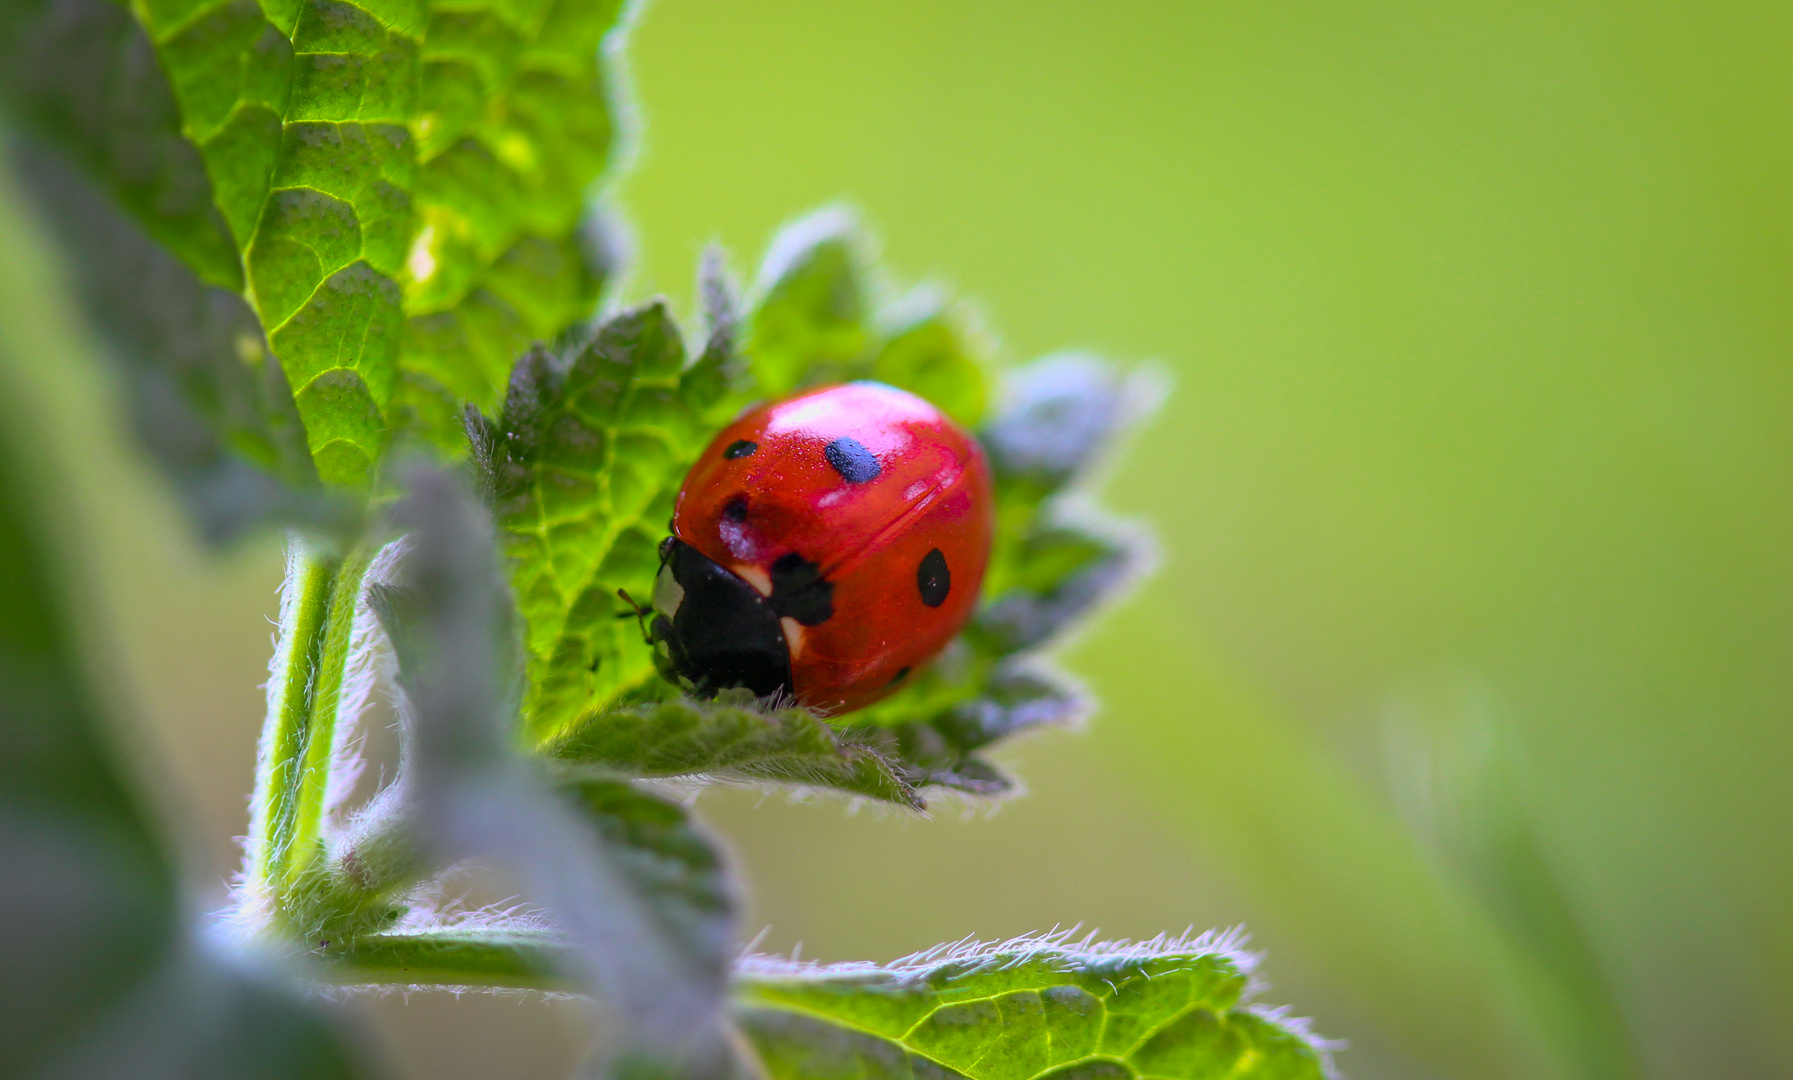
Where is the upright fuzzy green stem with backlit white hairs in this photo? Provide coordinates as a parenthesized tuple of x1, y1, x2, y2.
(247, 536, 371, 911)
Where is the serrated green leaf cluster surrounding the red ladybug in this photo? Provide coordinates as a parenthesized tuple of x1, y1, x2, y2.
(484, 212, 1149, 807)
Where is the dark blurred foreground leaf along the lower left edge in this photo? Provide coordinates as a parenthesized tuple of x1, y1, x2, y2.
(0, 256, 371, 1080)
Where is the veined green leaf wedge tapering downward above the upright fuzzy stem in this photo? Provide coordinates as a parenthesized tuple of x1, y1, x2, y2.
(149, 0, 423, 486)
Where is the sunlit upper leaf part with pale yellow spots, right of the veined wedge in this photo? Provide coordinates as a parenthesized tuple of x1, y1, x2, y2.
(402, 0, 624, 450)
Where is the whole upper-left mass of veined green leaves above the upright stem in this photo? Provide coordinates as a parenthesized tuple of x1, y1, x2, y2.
(0, 0, 620, 488)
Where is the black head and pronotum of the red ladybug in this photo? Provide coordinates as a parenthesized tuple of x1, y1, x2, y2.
(647, 536, 791, 698)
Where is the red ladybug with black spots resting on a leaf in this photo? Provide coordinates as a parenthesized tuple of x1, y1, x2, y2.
(645, 382, 995, 716)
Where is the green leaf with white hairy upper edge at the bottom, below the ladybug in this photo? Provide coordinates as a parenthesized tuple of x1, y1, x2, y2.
(735, 935, 1330, 1080)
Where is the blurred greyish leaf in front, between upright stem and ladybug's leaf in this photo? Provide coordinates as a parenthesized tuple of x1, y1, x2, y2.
(367, 466, 730, 1076)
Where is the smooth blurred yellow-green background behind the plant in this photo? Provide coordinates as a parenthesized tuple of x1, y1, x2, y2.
(24, 0, 1793, 1080)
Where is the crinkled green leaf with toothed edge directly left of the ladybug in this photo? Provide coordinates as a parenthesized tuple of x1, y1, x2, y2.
(470, 301, 732, 741)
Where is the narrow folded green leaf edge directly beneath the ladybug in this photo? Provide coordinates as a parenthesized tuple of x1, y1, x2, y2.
(545, 691, 922, 809)
